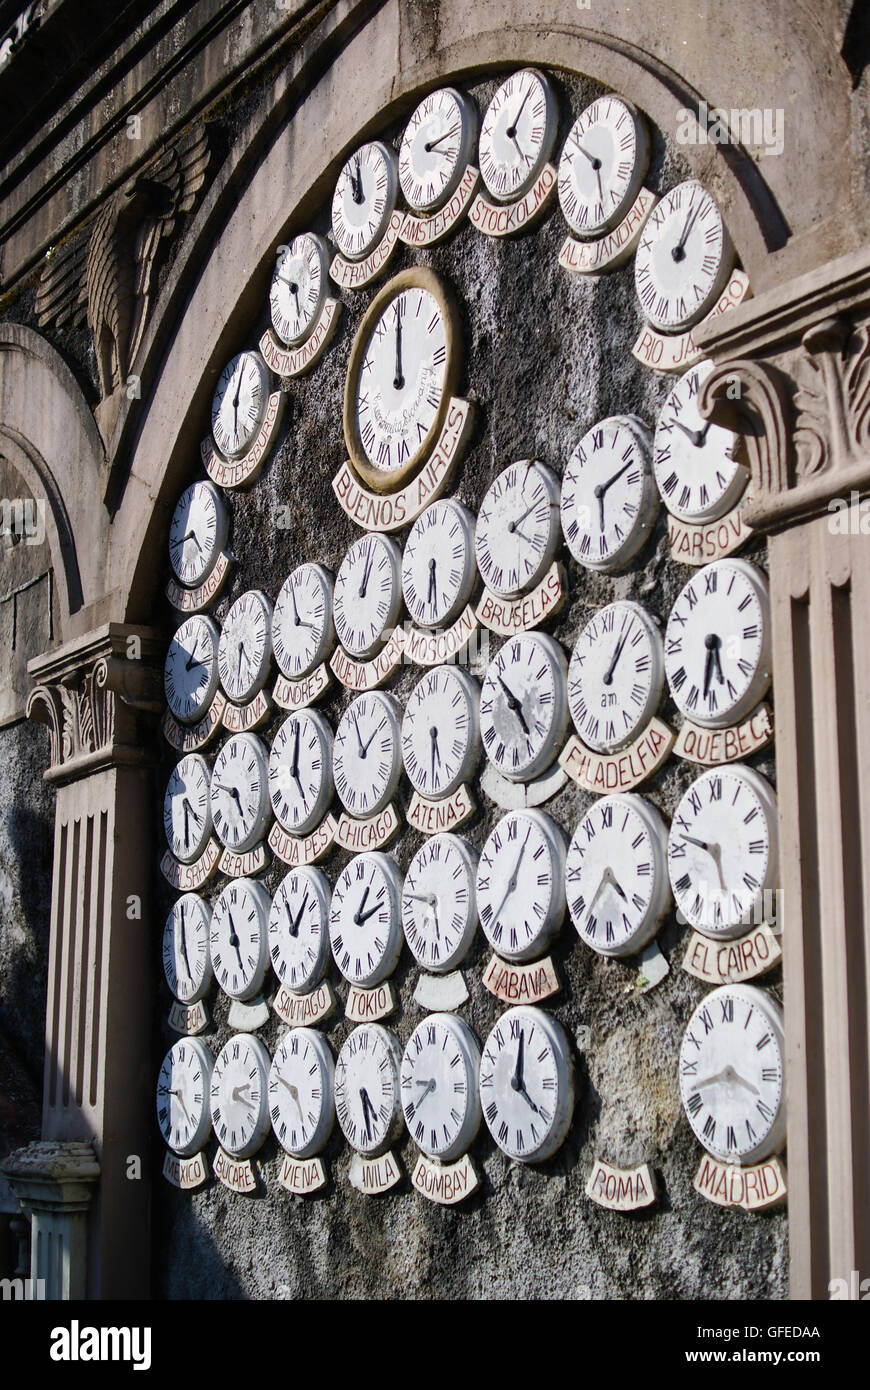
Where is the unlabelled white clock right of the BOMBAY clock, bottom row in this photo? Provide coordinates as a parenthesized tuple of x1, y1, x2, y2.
(481, 1005, 574, 1163)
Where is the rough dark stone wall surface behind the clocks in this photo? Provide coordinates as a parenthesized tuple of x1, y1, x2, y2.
(151, 67, 787, 1298)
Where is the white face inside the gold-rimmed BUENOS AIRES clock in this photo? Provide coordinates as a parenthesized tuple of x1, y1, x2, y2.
(354, 285, 448, 480)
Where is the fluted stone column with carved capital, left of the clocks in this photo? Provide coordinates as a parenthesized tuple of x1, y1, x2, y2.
(17, 623, 163, 1298)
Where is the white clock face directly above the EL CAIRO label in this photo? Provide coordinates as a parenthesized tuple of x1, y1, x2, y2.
(667, 763, 780, 940)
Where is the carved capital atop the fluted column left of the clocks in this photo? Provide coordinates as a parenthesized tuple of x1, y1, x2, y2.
(26, 623, 165, 783)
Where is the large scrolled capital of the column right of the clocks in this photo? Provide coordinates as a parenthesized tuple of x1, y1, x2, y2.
(696, 241, 870, 531)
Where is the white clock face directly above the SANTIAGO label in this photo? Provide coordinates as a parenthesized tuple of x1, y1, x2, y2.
(268, 866, 329, 994)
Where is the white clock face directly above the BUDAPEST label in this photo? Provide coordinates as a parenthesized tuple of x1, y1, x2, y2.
(268, 709, 332, 835)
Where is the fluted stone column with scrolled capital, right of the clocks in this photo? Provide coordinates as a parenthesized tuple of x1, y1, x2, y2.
(702, 252, 870, 1298)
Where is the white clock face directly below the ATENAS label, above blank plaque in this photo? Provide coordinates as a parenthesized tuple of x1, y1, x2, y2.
(402, 835, 477, 974)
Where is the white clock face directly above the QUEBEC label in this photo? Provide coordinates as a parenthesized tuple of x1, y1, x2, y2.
(664, 559, 770, 728)
